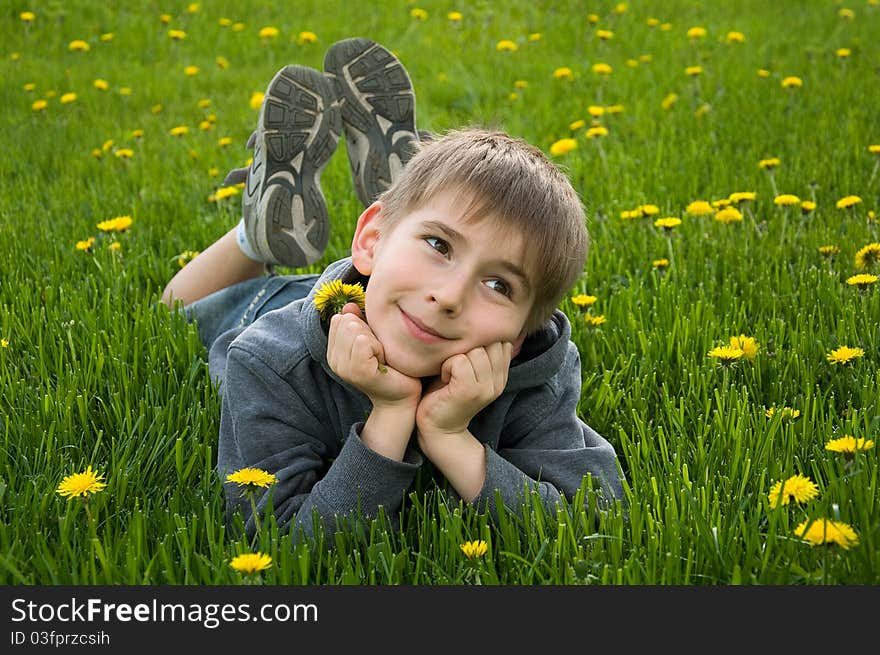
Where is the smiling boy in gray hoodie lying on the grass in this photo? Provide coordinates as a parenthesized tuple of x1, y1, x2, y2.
(163, 39, 623, 538)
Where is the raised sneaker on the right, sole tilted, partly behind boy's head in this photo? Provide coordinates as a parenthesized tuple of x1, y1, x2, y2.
(324, 38, 419, 207)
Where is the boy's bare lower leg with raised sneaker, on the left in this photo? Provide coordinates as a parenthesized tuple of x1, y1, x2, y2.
(162, 66, 341, 307)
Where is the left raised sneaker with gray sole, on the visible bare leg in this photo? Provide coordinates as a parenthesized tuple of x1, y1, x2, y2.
(242, 66, 342, 268)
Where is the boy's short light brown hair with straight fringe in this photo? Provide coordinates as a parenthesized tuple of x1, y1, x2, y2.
(379, 127, 589, 333)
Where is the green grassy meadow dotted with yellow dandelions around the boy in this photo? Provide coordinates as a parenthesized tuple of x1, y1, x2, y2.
(0, 0, 880, 585)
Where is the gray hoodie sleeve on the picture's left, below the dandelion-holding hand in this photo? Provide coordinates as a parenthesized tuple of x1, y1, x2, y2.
(217, 345, 421, 541)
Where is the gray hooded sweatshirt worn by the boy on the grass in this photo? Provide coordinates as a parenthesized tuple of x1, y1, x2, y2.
(209, 258, 623, 539)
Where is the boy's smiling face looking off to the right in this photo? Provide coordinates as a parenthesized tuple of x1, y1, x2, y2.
(352, 193, 534, 377)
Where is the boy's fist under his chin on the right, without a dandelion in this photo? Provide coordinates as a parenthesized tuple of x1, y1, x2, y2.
(416, 341, 513, 439)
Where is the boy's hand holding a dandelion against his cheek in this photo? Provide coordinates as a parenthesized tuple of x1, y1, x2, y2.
(327, 303, 422, 407)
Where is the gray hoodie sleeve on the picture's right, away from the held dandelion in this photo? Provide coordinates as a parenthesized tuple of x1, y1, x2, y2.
(473, 343, 623, 516)
